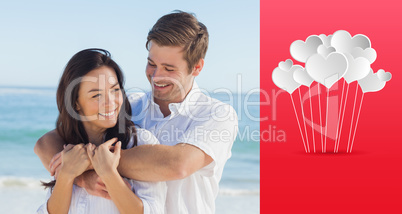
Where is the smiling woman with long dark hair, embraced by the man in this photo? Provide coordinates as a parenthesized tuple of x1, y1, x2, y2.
(38, 49, 166, 214)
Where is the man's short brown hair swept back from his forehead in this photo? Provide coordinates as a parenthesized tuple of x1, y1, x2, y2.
(146, 11, 208, 73)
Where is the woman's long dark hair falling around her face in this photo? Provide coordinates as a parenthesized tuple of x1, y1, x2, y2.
(43, 48, 137, 187)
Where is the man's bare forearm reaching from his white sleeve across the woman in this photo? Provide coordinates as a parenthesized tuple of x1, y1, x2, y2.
(118, 143, 213, 181)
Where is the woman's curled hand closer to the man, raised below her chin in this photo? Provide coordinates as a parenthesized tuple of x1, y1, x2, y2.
(87, 138, 121, 178)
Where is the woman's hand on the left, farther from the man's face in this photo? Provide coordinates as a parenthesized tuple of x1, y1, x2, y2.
(59, 144, 91, 179)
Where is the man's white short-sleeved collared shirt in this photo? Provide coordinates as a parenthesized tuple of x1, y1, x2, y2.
(129, 82, 238, 214)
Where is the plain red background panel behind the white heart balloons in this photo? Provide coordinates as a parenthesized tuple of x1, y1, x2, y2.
(260, 0, 402, 213)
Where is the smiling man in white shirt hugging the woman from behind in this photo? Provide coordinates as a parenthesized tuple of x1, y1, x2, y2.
(35, 11, 237, 214)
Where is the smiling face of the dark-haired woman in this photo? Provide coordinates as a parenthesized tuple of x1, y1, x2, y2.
(77, 66, 123, 129)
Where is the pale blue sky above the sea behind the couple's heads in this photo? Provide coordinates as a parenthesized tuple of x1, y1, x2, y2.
(0, 0, 259, 93)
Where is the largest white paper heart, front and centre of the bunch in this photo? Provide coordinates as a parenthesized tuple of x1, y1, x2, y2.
(306, 52, 348, 88)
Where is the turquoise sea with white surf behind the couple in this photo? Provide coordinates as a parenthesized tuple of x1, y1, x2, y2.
(0, 87, 260, 213)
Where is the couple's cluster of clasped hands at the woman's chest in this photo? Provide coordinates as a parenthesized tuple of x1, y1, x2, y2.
(49, 138, 131, 199)
